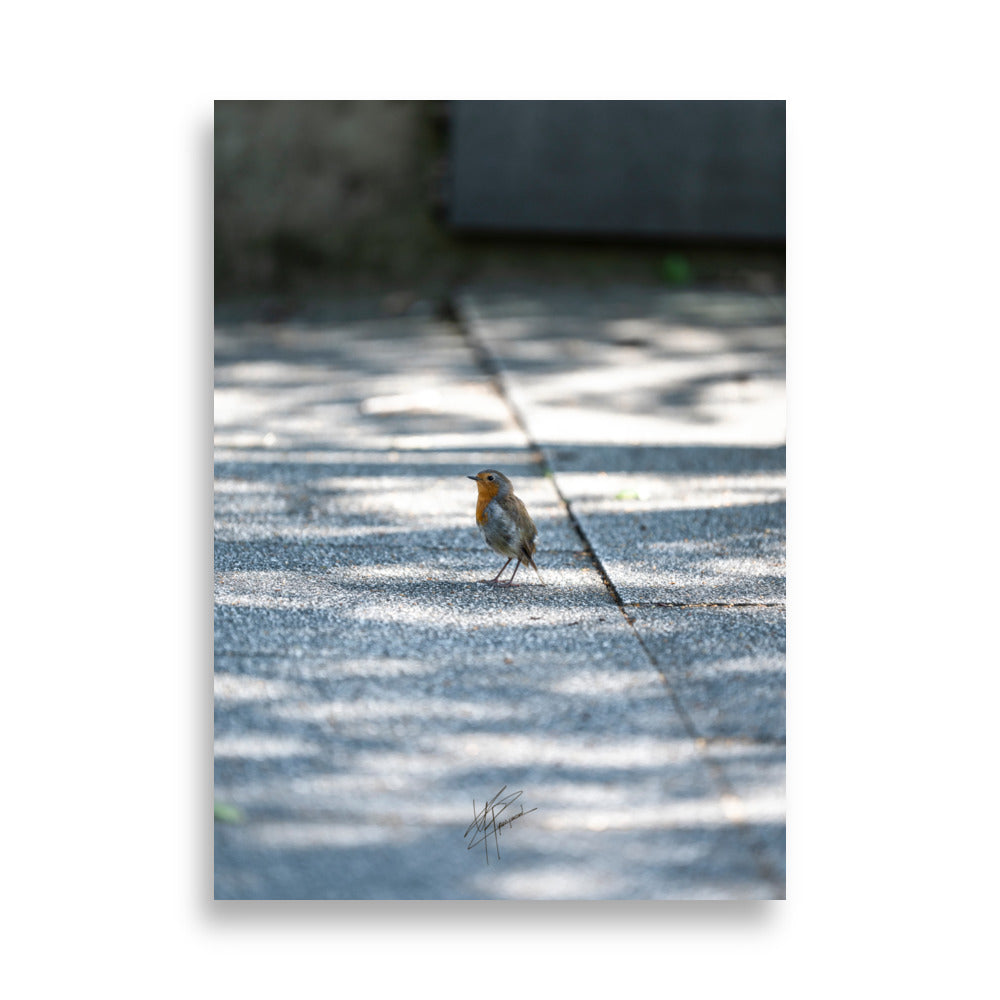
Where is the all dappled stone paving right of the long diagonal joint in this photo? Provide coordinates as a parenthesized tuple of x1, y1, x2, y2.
(460, 288, 786, 896)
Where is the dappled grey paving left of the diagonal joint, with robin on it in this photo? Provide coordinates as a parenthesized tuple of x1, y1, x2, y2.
(215, 294, 784, 899)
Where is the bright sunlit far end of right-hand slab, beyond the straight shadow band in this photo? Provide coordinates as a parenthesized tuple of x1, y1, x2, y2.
(463, 293, 785, 444)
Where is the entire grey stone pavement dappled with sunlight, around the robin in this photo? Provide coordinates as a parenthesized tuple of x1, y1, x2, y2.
(215, 295, 784, 899)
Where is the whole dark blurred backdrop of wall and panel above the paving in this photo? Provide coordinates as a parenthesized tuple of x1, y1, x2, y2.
(215, 101, 785, 314)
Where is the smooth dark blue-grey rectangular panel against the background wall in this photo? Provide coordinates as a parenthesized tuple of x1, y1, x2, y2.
(450, 101, 785, 240)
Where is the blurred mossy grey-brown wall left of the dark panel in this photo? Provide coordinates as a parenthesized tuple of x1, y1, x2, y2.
(215, 101, 444, 295)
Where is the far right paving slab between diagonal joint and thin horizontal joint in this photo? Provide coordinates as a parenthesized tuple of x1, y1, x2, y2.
(462, 289, 785, 604)
